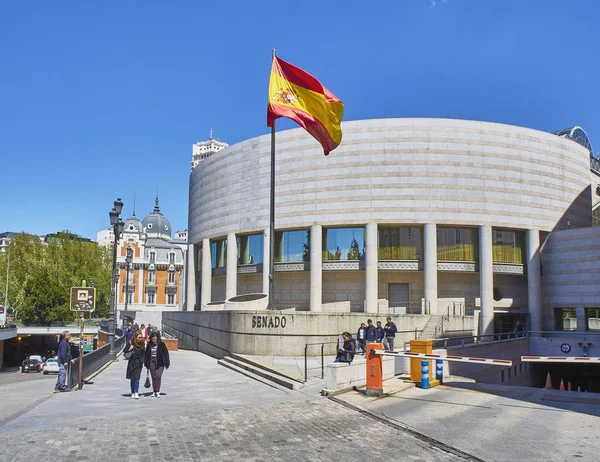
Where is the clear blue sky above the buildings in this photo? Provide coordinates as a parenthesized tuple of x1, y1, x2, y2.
(0, 0, 600, 242)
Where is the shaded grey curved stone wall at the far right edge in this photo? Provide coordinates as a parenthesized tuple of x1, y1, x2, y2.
(541, 228, 600, 330)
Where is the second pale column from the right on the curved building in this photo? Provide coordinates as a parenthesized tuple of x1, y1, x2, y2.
(479, 225, 494, 335)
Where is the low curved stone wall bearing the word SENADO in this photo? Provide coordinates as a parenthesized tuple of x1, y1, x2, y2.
(162, 311, 429, 358)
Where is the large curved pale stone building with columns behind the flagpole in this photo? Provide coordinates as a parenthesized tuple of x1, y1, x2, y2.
(187, 119, 597, 332)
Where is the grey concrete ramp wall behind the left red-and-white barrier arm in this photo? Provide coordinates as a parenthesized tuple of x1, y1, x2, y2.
(448, 338, 529, 384)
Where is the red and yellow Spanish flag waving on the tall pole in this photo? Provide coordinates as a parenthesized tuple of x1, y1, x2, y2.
(267, 56, 344, 155)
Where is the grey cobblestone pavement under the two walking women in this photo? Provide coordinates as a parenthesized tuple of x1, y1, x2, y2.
(0, 351, 474, 461)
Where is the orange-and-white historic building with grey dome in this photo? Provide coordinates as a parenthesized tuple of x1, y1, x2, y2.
(98, 197, 187, 326)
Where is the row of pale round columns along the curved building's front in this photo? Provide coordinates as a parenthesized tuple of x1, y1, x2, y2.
(193, 223, 542, 334)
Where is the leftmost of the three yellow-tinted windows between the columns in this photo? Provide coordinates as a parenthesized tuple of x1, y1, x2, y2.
(377, 227, 423, 260)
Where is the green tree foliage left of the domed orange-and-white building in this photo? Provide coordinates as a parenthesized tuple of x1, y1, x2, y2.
(0, 233, 112, 325)
